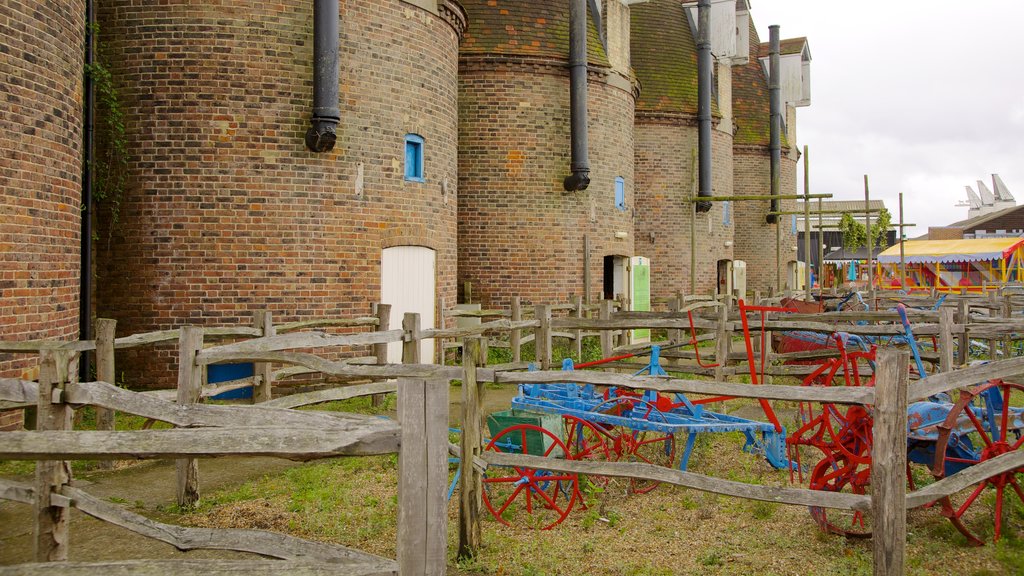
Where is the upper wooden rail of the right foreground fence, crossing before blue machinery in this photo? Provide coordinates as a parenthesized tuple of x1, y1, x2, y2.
(491, 367, 874, 404)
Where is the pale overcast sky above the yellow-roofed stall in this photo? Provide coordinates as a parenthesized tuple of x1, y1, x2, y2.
(751, 0, 1024, 238)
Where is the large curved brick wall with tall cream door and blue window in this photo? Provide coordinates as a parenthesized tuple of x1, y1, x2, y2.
(97, 0, 459, 385)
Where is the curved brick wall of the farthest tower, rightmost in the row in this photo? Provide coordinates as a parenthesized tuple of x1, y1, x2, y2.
(733, 147, 797, 295)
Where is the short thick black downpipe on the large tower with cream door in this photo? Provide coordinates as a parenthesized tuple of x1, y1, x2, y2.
(306, 0, 341, 152)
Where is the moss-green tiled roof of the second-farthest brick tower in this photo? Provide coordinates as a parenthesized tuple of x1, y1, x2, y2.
(630, 0, 697, 115)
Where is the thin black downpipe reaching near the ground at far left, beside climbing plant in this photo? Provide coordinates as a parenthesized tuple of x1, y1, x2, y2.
(78, 0, 96, 381)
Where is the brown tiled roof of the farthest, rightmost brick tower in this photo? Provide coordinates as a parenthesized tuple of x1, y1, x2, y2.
(732, 18, 770, 147)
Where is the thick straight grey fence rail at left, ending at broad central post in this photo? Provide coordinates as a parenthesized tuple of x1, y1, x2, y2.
(0, 418, 398, 459)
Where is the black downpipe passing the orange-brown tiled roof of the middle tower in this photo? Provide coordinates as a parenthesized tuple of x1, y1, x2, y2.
(562, 0, 590, 192)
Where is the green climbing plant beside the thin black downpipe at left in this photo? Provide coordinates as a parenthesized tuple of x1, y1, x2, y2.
(85, 25, 128, 239)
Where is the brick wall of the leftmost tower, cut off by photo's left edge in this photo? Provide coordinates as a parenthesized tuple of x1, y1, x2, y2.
(0, 0, 85, 428)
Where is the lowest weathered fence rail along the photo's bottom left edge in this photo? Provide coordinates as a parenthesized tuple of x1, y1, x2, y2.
(0, 559, 398, 576)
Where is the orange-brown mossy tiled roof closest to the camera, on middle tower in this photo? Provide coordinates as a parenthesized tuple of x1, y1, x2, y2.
(459, 0, 610, 67)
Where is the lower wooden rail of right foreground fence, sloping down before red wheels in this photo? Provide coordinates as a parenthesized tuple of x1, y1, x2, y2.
(480, 452, 871, 511)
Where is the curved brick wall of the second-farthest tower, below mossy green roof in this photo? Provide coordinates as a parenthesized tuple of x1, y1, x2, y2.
(636, 117, 735, 297)
